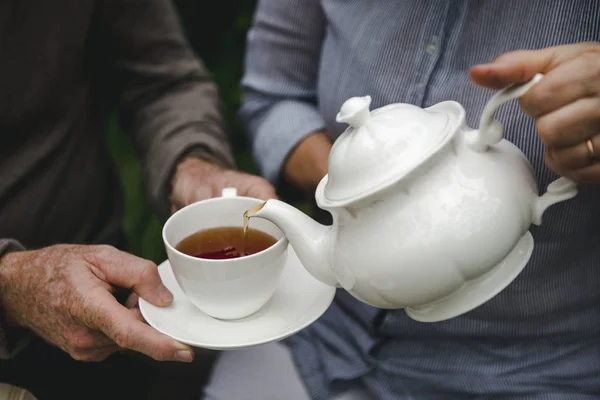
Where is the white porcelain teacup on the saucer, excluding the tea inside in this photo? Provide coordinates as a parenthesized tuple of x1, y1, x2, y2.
(162, 188, 288, 320)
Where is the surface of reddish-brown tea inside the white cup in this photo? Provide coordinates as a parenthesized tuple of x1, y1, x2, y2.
(175, 227, 277, 260)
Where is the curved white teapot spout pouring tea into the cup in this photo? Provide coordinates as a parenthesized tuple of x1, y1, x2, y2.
(245, 199, 338, 287)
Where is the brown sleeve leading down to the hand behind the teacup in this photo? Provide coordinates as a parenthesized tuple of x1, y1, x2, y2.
(101, 0, 234, 219)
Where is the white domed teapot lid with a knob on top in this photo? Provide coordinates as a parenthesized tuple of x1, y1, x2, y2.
(317, 96, 464, 205)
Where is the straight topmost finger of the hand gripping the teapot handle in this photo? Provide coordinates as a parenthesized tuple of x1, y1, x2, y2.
(470, 43, 597, 89)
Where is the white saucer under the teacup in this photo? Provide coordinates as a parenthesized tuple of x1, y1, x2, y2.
(139, 246, 335, 350)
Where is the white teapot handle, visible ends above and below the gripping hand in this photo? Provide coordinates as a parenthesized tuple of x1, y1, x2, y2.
(467, 74, 577, 225)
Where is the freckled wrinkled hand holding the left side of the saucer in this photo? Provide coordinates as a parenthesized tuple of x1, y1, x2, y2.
(0, 245, 193, 362)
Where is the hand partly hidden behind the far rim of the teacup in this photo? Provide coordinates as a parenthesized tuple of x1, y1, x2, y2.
(171, 157, 277, 211)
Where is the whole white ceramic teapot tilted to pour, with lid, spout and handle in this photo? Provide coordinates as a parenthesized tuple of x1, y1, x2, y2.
(249, 75, 577, 322)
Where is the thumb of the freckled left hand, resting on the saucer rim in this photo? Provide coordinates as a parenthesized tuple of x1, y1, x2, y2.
(93, 247, 173, 306)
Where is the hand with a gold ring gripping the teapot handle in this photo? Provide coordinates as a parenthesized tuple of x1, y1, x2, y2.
(471, 42, 600, 183)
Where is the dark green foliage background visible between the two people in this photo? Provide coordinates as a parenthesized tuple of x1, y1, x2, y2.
(106, 0, 257, 263)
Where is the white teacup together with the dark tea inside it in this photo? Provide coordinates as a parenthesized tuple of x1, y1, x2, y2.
(162, 188, 289, 320)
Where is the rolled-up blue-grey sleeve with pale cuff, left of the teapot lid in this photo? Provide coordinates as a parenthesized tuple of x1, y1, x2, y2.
(240, 0, 325, 183)
